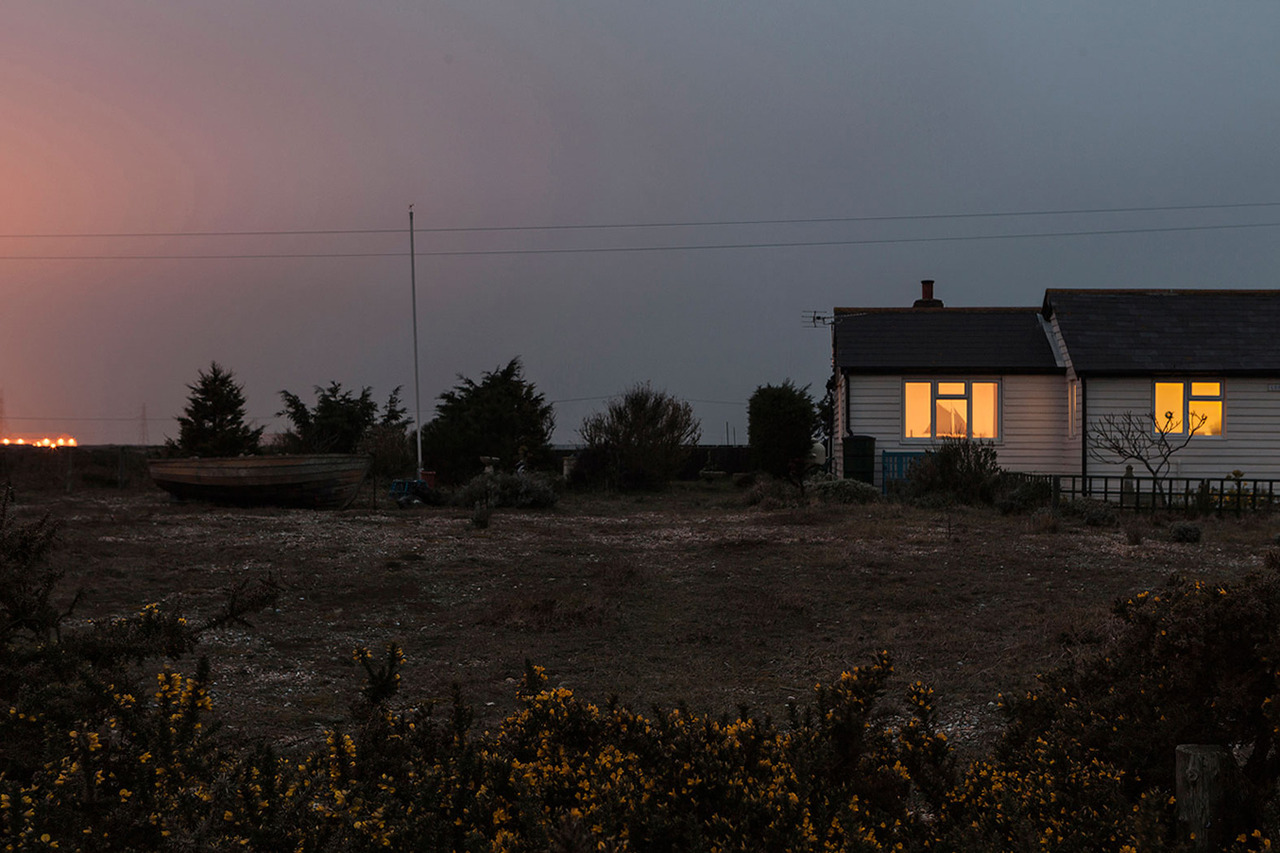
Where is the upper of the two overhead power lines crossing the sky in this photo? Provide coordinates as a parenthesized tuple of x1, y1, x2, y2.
(0, 201, 1280, 240)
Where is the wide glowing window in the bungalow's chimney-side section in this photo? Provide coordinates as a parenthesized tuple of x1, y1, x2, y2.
(902, 380, 1000, 439)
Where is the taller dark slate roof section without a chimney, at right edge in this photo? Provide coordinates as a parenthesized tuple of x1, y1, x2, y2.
(1042, 289, 1280, 375)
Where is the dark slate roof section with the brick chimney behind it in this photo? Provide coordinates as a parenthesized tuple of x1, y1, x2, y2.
(835, 307, 1064, 373)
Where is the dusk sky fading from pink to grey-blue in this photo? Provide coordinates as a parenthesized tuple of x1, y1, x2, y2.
(0, 0, 1280, 443)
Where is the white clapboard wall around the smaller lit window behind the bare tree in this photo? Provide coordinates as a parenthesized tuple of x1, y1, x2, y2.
(1087, 377, 1280, 479)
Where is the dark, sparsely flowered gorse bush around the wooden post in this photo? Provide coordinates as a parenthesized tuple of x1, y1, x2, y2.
(997, 563, 1280, 844)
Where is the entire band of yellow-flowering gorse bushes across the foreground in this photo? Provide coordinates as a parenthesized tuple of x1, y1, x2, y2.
(12, 489, 1280, 853)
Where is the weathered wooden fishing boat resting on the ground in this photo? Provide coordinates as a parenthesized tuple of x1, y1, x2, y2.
(150, 453, 370, 510)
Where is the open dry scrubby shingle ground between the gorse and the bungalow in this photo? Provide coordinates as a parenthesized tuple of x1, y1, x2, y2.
(19, 484, 1276, 749)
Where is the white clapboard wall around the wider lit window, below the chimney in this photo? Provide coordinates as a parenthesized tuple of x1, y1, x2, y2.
(837, 374, 1080, 484)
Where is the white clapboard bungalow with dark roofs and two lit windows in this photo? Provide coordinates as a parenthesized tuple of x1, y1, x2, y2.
(832, 282, 1280, 485)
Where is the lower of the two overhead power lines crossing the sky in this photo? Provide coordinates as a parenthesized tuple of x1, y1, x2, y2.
(0, 222, 1280, 261)
